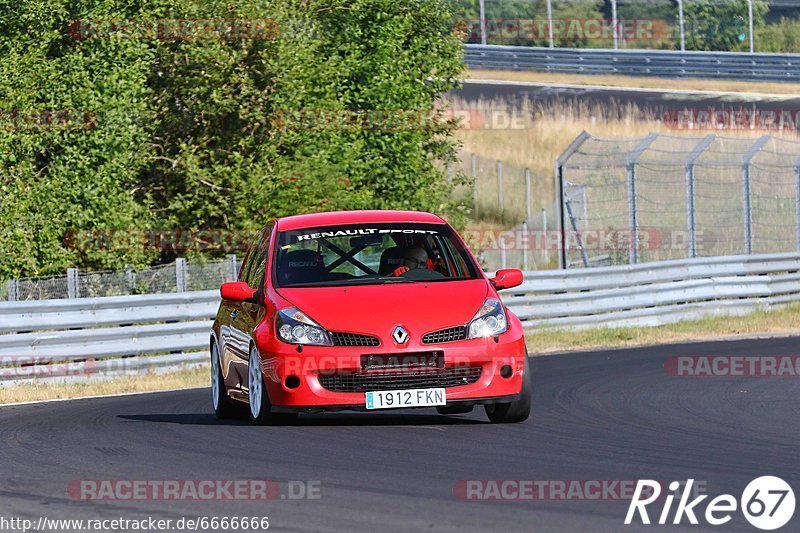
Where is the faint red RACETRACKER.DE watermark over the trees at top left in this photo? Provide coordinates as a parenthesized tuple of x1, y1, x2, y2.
(67, 18, 278, 41)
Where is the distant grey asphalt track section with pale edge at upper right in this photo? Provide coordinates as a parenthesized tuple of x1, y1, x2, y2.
(453, 80, 800, 113)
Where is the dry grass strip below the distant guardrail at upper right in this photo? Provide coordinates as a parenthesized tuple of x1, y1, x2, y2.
(466, 70, 800, 95)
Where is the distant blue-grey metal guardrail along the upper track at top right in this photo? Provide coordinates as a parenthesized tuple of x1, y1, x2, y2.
(464, 44, 800, 81)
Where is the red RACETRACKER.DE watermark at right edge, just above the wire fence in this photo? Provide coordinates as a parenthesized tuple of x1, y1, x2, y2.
(661, 107, 800, 132)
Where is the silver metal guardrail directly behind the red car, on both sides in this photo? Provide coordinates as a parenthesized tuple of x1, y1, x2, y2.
(0, 253, 800, 383)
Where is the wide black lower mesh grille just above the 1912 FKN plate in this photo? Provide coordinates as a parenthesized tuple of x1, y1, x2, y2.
(319, 366, 481, 392)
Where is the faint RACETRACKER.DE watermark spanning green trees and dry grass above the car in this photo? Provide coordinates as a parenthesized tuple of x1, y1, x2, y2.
(274, 107, 533, 132)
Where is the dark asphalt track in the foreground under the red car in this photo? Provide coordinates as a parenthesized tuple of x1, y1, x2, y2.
(0, 338, 800, 532)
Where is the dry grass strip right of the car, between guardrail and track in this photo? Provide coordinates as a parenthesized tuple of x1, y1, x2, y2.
(526, 304, 800, 355)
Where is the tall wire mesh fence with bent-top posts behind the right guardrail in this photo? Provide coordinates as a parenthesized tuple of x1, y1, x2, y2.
(557, 132, 800, 268)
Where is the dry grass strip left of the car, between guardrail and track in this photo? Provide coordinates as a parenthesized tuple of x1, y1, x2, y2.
(0, 367, 210, 404)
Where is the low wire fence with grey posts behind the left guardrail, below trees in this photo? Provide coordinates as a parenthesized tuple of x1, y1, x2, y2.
(0, 255, 241, 301)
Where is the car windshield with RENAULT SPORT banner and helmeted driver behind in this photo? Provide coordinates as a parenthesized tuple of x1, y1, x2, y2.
(275, 223, 479, 287)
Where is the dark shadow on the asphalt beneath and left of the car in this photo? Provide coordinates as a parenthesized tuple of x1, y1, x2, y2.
(117, 413, 489, 427)
